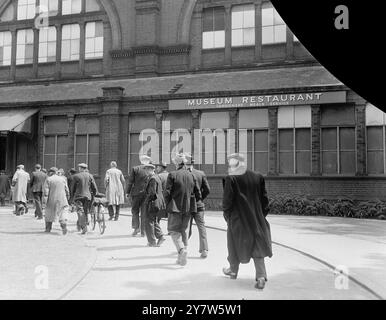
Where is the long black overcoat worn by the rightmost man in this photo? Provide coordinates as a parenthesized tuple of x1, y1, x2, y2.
(223, 169, 272, 263)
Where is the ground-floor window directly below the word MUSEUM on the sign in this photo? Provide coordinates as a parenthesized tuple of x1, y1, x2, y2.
(199, 112, 229, 174)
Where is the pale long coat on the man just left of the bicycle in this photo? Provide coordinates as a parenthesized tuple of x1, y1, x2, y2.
(43, 175, 70, 222)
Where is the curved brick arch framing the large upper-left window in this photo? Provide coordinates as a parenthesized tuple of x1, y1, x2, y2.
(0, 0, 122, 49)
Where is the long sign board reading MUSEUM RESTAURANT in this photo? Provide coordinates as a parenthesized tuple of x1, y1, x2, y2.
(169, 91, 346, 110)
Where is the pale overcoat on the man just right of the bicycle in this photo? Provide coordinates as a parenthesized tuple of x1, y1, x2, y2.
(105, 168, 125, 205)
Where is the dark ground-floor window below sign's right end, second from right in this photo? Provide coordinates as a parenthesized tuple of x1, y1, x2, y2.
(321, 106, 356, 174)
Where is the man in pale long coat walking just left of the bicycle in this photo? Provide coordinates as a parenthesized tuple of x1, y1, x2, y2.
(43, 167, 70, 235)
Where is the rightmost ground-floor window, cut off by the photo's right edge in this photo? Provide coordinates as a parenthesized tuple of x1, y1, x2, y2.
(366, 104, 386, 174)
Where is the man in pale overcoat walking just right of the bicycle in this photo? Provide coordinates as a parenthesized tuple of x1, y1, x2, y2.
(105, 161, 125, 221)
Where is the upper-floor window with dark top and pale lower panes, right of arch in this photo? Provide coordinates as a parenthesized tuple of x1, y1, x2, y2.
(202, 7, 225, 49)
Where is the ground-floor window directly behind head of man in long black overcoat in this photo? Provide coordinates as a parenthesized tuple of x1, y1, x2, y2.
(239, 109, 268, 174)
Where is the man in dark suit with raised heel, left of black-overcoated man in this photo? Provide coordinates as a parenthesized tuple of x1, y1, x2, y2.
(164, 154, 201, 266)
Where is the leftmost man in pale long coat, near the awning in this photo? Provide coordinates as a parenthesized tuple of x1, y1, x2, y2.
(12, 164, 30, 216)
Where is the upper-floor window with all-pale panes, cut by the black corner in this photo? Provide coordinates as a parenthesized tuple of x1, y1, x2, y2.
(261, 3, 287, 44)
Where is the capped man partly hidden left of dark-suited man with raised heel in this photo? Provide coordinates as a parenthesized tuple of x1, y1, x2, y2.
(145, 164, 166, 247)
